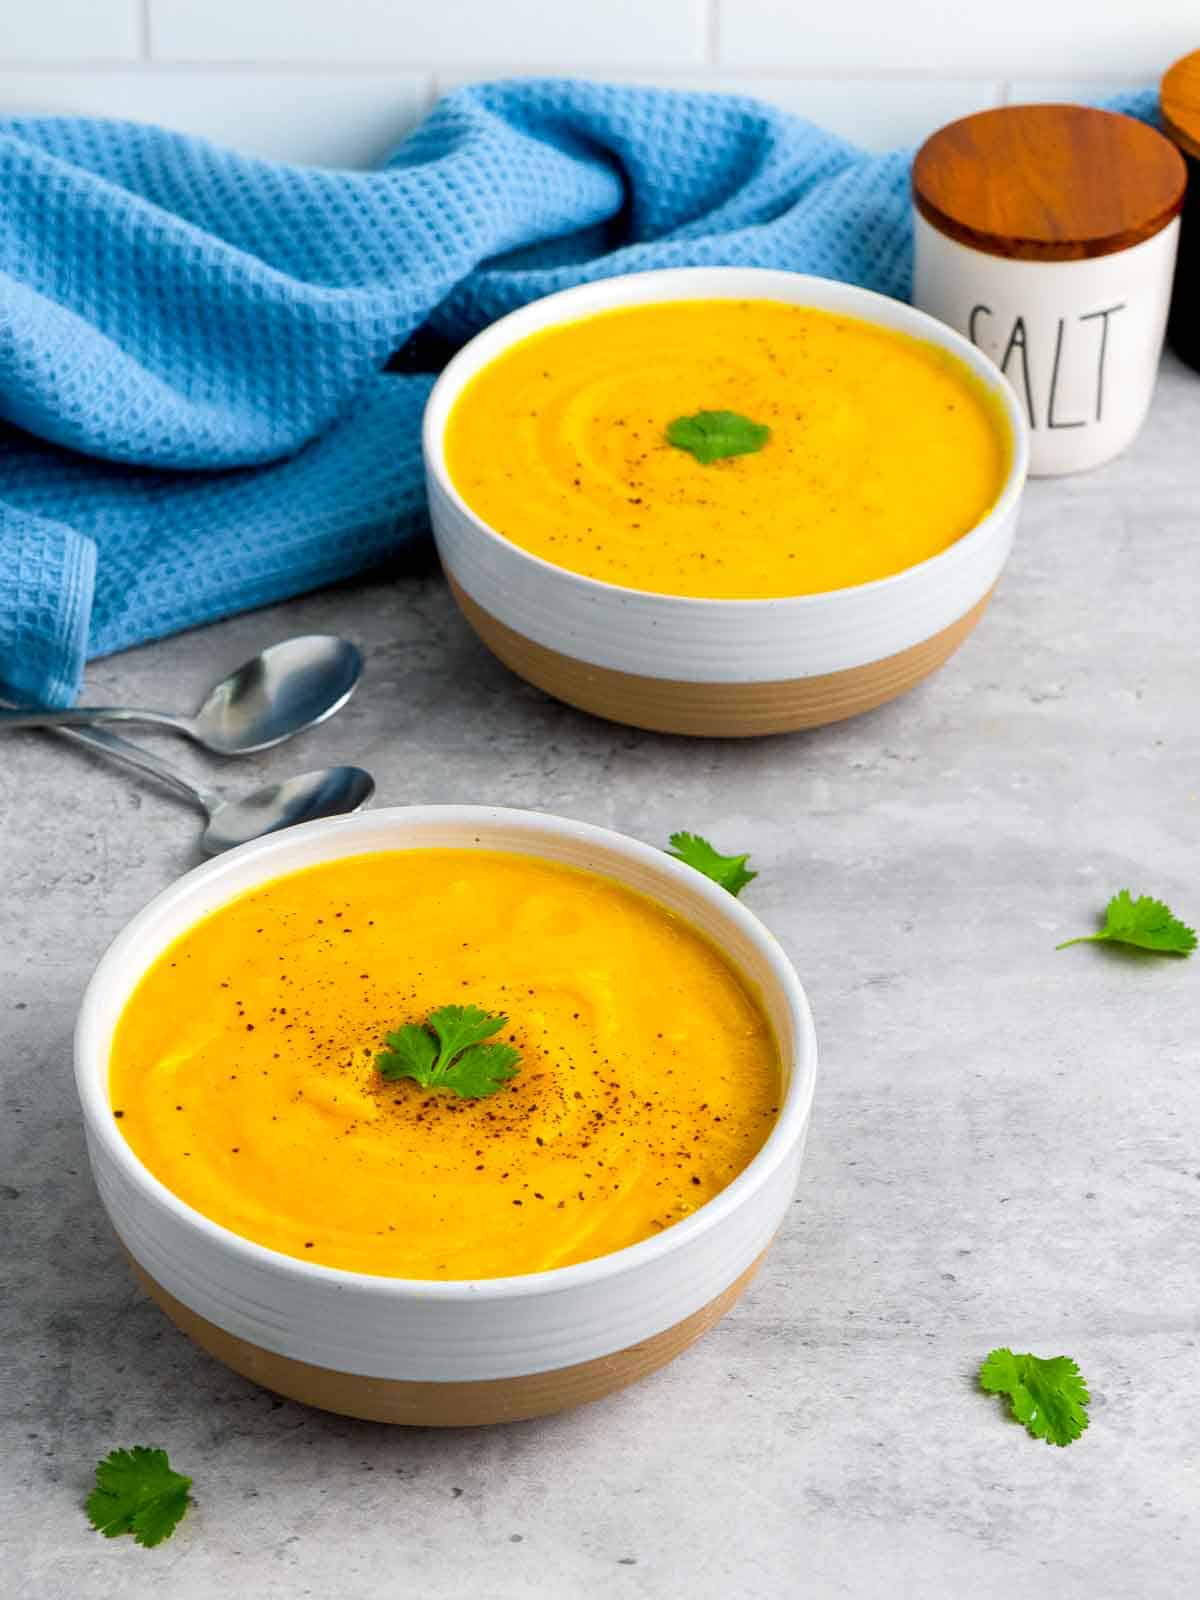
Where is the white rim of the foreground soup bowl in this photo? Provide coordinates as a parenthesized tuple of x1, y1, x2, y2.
(74, 805, 818, 1302)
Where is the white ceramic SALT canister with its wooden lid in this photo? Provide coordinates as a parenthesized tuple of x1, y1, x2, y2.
(912, 106, 1187, 475)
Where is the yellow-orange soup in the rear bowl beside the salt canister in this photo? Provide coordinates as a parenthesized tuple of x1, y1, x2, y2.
(445, 299, 1010, 598)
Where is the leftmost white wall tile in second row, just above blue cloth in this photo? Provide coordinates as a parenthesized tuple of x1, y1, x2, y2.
(0, 66, 432, 168)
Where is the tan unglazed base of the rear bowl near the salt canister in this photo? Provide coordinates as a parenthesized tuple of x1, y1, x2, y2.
(446, 574, 994, 739)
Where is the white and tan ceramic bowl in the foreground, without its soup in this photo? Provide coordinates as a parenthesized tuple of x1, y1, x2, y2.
(75, 806, 816, 1426)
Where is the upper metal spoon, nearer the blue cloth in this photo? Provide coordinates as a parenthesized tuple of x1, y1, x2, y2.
(0, 634, 363, 755)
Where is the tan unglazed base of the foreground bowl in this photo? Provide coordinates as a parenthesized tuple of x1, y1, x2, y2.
(130, 1251, 766, 1427)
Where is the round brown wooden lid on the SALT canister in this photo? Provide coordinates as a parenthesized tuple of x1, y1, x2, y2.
(912, 106, 1187, 261)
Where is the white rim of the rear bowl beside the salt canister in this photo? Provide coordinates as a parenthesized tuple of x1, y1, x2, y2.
(421, 267, 1030, 610)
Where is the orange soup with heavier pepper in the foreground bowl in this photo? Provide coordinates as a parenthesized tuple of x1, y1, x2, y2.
(109, 850, 781, 1278)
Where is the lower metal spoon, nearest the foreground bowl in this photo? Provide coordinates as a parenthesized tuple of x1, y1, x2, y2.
(59, 728, 374, 856)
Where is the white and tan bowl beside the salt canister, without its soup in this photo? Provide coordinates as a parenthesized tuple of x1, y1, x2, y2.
(424, 267, 1029, 736)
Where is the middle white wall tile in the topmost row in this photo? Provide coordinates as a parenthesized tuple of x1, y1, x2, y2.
(149, 0, 709, 70)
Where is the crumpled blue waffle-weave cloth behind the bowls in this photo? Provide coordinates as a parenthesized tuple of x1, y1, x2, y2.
(0, 80, 1152, 704)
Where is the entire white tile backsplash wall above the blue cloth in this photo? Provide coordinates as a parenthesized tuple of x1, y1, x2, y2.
(0, 0, 1200, 166)
